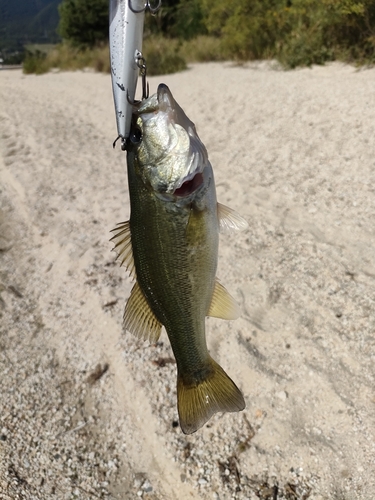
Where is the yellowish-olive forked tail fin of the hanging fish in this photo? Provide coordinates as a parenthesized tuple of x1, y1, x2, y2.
(177, 358, 245, 434)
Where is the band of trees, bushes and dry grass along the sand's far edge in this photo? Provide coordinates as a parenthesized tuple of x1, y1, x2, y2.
(21, 0, 375, 74)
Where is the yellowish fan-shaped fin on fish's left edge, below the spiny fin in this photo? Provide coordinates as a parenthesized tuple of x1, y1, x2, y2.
(124, 282, 162, 344)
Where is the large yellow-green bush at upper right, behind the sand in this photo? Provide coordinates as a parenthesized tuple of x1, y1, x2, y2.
(202, 0, 375, 67)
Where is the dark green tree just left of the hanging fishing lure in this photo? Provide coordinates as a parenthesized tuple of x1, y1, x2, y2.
(58, 0, 108, 47)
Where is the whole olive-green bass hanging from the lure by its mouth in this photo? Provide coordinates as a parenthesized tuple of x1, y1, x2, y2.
(111, 84, 247, 434)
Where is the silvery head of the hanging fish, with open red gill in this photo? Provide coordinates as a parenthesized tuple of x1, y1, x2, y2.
(128, 84, 209, 197)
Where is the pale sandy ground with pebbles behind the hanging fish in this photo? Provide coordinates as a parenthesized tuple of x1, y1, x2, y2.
(0, 63, 375, 500)
